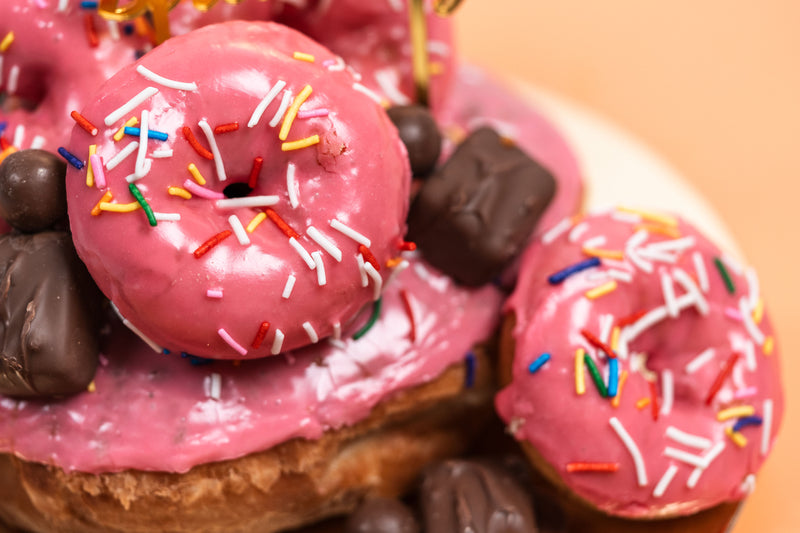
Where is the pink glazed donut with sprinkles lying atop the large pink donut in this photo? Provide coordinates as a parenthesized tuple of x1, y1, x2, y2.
(67, 22, 410, 358)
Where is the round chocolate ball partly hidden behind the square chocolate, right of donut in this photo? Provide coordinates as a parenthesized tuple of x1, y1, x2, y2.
(388, 105, 442, 178)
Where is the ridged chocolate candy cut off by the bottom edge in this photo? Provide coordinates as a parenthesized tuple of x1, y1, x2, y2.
(420, 460, 538, 533)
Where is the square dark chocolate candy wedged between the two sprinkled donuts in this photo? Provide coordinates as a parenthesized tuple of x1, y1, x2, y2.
(408, 128, 556, 286)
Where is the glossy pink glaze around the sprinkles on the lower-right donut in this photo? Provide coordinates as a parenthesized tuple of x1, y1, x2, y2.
(496, 214, 783, 517)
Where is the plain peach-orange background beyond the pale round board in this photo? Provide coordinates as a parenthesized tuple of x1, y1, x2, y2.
(458, 0, 800, 533)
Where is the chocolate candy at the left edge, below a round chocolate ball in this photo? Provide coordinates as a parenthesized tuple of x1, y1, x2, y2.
(0, 232, 101, 396)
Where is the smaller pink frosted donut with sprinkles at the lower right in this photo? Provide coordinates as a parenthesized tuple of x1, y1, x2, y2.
(496, 211, 783, 517)
